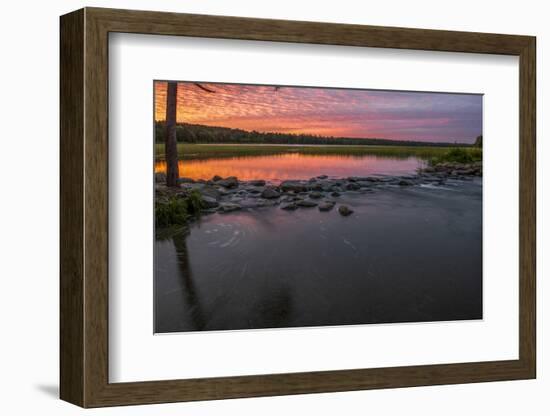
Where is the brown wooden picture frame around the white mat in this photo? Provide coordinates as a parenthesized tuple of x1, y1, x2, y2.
(60, 8, 536, 407)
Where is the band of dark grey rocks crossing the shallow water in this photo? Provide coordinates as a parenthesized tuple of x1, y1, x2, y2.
(155, 162, 482, 216)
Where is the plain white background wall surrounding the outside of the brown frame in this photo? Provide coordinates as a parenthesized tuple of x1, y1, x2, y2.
(0, 0, 550, 416)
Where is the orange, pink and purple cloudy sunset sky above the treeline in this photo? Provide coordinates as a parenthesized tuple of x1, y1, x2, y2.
(155, 81, 482, 143)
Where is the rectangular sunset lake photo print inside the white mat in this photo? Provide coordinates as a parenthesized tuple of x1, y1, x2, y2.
(152, 80, 483, 333)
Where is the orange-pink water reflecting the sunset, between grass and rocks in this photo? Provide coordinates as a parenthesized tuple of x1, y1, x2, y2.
(155, 153, 424, 182)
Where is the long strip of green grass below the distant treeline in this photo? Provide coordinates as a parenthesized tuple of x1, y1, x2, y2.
(155, 143, 481, 160)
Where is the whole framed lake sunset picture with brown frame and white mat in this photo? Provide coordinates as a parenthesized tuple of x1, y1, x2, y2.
(60, 8, 536, 407)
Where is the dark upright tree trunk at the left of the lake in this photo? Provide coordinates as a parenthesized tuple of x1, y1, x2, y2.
(164, 82, 179, 186)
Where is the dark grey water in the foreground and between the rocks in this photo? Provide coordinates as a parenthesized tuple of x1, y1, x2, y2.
(155, 180, 482, 332)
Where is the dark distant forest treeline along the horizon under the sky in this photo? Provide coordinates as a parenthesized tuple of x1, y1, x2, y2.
(155, 121, 481, 147)
